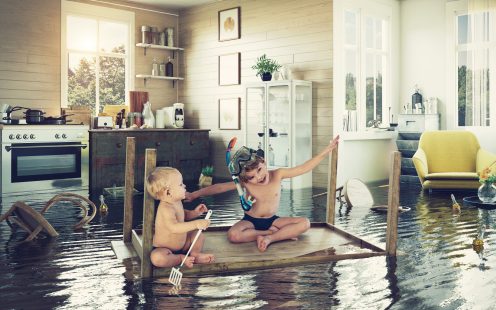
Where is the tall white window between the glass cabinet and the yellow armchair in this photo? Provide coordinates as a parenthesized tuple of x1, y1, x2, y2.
(333, 0, 391, 131)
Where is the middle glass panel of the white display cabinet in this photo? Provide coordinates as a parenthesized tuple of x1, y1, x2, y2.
(266, 84, 291, 167)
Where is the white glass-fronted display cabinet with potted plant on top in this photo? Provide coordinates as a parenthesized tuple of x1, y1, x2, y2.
(245, 80, 312, 189)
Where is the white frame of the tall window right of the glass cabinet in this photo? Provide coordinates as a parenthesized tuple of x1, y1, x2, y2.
(333, 0, 395, 133)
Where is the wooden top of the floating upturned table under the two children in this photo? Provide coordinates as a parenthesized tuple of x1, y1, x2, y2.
(124, 223, 385, 277)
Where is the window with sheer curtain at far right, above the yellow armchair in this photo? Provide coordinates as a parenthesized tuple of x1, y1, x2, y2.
(455, 8, 496, 127)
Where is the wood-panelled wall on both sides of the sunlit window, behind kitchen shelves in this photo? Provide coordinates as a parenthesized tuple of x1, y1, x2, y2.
(0, 0, 180, 117)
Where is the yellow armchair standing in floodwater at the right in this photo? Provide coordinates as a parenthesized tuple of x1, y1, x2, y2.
(412, 130, 496, 189)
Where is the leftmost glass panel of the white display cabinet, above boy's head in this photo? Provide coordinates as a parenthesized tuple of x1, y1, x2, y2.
(245, 86, 267, 154)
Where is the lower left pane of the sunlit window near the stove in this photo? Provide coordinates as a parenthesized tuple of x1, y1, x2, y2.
(67, 53, 96, 110)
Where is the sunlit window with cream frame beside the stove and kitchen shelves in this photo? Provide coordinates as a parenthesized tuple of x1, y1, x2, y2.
(61, 1, 134, 115)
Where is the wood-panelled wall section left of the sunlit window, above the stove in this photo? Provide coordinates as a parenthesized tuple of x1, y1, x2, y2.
(0, 0, 60, 116)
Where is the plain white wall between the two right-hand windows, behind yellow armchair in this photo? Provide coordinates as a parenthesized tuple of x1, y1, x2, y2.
(400, 0, 496, 153)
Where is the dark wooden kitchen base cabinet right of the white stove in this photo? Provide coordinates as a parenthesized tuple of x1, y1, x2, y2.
(89, 129, 210, 193)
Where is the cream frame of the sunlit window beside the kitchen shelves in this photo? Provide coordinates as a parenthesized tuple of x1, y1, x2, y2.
(60, 0, 135, 112)
